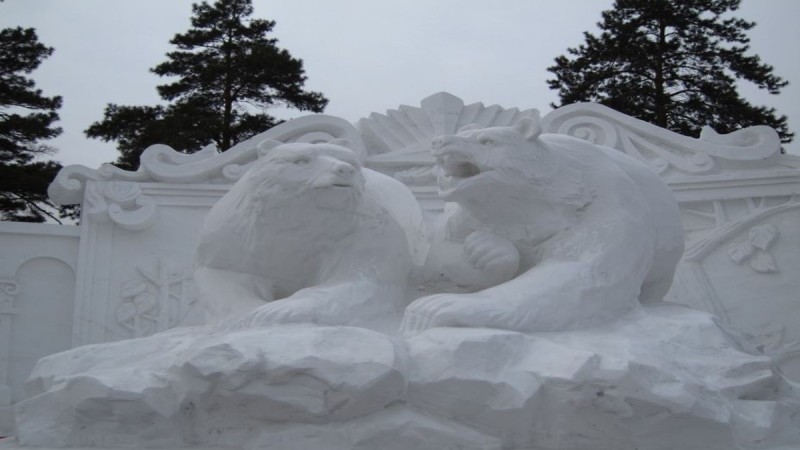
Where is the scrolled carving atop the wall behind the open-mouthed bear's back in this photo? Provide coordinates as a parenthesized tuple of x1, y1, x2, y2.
(543, 103, 780, 175)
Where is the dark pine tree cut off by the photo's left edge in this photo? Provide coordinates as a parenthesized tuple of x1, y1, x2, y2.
(0, 27, 61, 222)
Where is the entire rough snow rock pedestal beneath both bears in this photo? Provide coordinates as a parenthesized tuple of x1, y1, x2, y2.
(10, 306, 799, 450)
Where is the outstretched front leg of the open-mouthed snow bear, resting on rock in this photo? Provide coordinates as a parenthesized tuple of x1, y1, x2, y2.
(402, 221, 654, 335)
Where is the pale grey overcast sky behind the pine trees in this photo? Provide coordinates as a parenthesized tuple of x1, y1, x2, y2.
(0, 0, 800, 168)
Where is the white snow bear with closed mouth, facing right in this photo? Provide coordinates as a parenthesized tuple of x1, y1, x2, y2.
(195, 141, 421, 327)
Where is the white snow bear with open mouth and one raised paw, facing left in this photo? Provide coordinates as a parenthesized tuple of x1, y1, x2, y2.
(402, 114, 684, 334)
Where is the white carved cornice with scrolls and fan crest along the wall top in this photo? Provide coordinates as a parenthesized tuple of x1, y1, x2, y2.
(48, 92, 800, 207)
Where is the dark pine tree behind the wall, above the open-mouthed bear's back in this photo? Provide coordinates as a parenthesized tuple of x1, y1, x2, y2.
(548, 0, 793, 143)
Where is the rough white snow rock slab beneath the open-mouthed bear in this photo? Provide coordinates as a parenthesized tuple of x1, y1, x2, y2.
(408, 306, 784, 450)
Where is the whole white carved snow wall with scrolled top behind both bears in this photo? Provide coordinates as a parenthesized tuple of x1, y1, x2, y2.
(0, 93, 800, 436)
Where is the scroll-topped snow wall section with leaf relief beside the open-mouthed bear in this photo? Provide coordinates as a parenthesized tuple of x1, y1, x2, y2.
(545, 104, 800, 356)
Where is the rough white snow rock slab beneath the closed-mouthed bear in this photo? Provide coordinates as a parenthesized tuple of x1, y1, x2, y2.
(17, 326, 406, 447)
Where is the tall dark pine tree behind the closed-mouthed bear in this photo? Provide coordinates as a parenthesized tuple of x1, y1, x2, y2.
(86, 0, 328, 169)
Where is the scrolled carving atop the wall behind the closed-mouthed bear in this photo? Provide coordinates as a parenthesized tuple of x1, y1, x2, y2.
(48, 114, 366, 205)
